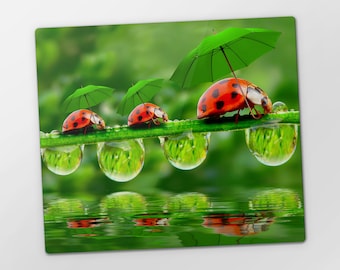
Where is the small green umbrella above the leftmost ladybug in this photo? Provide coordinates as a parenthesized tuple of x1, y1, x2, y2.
(62, 85, 113, 112)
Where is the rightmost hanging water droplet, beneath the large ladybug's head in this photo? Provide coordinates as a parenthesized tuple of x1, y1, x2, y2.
(245, 124, 298, 166)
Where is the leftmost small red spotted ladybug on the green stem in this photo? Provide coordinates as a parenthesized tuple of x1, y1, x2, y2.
(62, 109, 105, 134)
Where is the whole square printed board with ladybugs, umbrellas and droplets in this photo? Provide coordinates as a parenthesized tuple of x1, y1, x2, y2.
(35, 17, 305, 253)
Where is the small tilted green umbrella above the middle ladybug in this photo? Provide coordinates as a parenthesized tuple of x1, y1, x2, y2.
(117, 78, 175, 115)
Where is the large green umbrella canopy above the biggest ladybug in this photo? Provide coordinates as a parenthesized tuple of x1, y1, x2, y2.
(171, 28, 281, 88)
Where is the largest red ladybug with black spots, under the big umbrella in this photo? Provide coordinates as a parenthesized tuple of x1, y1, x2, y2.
(197, 78, 272, 119)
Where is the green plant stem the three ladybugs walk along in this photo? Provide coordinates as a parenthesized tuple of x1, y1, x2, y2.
(40, 111, 300, 148)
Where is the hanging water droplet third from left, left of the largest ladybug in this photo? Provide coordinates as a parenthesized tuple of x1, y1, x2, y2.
(160, 132, 210, 170)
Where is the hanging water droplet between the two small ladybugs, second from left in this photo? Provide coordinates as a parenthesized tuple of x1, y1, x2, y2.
(97, 139, 145, 182)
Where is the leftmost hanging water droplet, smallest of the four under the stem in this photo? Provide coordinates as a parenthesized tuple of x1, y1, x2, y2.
(41, 145, 84, 175)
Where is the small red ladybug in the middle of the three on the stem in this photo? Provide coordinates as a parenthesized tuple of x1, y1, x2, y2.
(128, 103, 169, 127)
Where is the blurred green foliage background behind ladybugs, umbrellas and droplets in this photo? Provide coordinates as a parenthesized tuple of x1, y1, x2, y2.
(36, 17, 303, 207)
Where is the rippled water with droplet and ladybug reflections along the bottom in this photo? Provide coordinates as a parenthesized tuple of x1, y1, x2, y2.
(45, 188, 304, 252)
